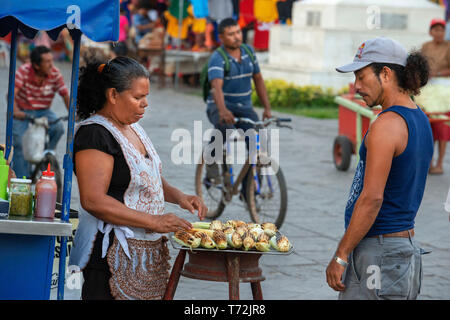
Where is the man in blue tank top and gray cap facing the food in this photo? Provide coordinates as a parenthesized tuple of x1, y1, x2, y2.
(326, 38, 433, 299)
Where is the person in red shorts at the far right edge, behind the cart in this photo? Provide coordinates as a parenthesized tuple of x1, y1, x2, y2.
(422, 19, 450, 174)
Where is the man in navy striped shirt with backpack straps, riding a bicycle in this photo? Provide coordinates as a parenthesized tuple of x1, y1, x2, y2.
(206, 18, 271, 198)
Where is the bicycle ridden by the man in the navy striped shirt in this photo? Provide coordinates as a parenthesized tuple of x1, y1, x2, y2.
(195, 118, 292, 228)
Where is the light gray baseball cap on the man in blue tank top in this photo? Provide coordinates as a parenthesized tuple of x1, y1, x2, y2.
(336, 37, 408, 72)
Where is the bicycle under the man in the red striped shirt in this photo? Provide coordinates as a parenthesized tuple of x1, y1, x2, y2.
(25, 116, 69, 203)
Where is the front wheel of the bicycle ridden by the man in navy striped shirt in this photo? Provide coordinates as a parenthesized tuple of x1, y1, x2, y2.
(246, 160, 287, 229)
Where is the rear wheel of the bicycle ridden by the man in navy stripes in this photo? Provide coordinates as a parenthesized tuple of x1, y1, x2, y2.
(195, 156, 225, 219)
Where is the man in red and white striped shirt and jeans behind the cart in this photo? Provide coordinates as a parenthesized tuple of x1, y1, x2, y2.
(12, 46, 70, 177)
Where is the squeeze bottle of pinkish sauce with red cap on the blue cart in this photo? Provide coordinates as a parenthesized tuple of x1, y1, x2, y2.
(34, 163, 58, 219)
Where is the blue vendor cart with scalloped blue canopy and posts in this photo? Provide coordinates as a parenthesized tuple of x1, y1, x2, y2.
(0, 0, 119, 300)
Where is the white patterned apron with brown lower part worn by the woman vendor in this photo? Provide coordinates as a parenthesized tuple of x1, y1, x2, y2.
(69, 115, 169, 299)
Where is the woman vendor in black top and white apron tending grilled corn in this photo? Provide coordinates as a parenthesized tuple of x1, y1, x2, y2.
(69, 57, 207, 299)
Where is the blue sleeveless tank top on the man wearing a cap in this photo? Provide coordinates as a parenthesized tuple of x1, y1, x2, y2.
(345, 106, 433, 236)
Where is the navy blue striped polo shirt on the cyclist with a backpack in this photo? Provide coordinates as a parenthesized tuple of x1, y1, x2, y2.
(206, 46, 261, 108)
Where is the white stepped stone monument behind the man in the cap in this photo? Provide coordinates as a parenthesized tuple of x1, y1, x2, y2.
(261, 0, 444, 89)
